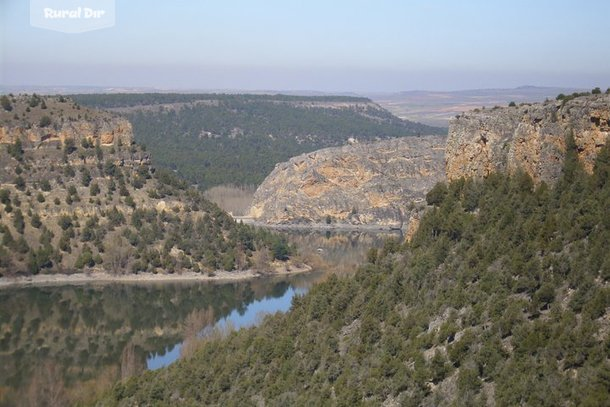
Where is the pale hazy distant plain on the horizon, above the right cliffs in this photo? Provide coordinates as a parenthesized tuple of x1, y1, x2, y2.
(370, 86, 590, 127)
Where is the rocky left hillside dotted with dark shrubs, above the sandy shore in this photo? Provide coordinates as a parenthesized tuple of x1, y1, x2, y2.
(0, 95, 290, 276)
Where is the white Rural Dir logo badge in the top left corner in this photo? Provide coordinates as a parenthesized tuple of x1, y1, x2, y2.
(30, 0, 115, 34)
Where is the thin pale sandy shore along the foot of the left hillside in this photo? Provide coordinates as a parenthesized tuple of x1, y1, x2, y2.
(0, 264, 312, 289)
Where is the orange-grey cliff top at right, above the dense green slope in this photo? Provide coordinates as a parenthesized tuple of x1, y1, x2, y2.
(445, 95, 610, 183)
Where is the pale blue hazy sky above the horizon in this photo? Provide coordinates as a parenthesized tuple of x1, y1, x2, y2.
(0, 0, 610, 92)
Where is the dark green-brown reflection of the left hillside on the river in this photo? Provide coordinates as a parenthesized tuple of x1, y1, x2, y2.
(0, 279, 290, 406)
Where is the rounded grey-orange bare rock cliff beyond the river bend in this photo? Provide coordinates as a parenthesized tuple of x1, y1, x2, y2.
(250, 136, 445, 227)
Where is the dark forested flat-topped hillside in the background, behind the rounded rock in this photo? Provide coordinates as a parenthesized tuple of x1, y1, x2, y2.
(72, 94, 446, 189)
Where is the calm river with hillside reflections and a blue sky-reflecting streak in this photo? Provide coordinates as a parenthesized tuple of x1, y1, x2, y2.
(0, 231, 390, 406)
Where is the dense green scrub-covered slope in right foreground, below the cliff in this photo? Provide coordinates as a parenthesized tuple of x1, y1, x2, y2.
(101, 135, 610, 406)
